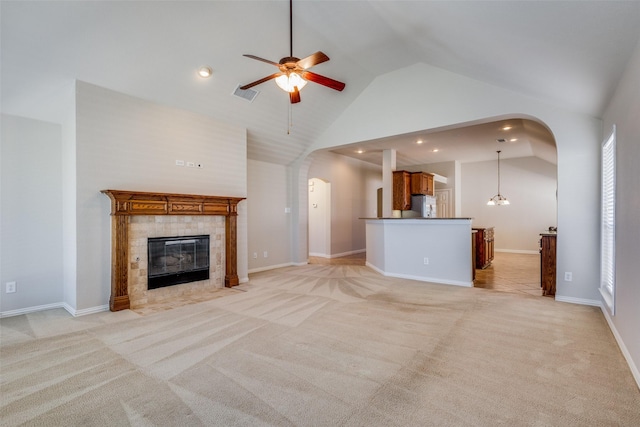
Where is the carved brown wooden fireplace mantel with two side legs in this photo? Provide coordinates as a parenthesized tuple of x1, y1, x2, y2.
(101, 190, 245, 311)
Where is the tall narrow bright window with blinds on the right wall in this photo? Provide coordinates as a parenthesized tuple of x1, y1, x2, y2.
(600, 126, 616, 316)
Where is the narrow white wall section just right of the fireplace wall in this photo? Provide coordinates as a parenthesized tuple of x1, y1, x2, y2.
(245, 160, 291, 272)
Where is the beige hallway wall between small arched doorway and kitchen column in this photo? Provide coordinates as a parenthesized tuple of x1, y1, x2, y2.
(304, 152, 382, 259)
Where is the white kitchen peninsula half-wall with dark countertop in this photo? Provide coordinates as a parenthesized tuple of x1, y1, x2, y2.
(361, 217, 473, 287)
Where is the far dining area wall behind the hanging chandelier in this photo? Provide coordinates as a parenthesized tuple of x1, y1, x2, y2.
(462, 157, 558, 254)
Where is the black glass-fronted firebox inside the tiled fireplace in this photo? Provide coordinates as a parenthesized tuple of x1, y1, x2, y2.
(147, 235, 209, 289)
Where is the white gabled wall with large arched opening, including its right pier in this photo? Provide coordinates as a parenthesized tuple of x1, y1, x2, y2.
(294, 64, 602, 304)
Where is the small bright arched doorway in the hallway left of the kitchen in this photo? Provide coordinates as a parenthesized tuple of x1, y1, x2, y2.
(308, 178, 331, 258)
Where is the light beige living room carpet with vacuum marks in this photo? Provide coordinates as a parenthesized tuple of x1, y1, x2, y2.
(0, 265, 640, 426)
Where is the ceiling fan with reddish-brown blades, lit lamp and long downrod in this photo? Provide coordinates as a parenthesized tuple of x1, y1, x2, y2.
(240, 0, 345, 104)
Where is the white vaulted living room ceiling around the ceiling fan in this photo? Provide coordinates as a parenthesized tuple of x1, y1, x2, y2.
(0, 0, 640, 164)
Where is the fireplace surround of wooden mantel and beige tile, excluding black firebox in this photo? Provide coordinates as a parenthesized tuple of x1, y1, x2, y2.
(102, 190, 244, 311)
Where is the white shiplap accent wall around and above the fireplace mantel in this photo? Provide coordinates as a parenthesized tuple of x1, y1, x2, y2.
(73, 81, 247, 310)
